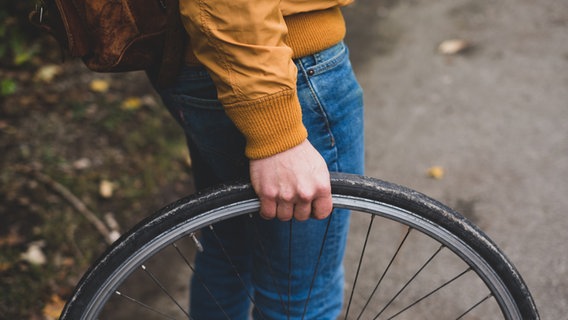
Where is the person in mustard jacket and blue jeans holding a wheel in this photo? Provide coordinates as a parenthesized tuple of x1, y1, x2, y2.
(152, 0, 363, 319)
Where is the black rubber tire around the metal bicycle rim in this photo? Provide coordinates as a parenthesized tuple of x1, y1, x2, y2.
(60, 173, 539, 320)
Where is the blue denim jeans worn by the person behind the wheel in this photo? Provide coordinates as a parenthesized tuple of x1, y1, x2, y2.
(160, 43, 363, 320)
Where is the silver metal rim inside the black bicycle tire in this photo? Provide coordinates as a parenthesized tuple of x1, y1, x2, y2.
(82, 194, 522, 320)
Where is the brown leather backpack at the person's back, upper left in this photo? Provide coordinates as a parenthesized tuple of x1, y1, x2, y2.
(30, 0, 185, 86)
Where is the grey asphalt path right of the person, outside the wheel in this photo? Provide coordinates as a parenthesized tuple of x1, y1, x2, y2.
(345, 0, 568, 319)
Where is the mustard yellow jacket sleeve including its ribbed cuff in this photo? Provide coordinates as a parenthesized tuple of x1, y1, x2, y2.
(180, 0, 307, 159)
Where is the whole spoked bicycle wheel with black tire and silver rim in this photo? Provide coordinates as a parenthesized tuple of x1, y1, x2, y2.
(61, 174, 539, 319)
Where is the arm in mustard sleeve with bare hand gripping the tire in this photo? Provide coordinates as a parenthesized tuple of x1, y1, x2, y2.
(181, 0, 332, 220)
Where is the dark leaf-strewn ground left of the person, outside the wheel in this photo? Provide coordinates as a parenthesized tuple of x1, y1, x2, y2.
(0, 0, 192, 319)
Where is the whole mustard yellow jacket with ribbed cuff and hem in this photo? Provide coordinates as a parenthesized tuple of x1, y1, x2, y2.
(180, 0, 353, 159)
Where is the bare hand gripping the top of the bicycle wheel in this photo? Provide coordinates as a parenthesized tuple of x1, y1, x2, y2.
(250, 140, 333, 221)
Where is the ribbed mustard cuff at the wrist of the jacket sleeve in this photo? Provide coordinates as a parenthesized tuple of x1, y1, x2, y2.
(225, 90, 308, 159)
